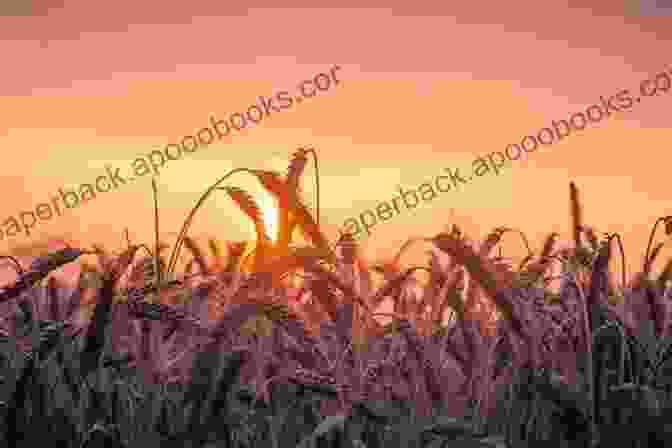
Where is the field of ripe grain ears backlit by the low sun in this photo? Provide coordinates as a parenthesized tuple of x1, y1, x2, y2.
(0, 148, 672, 448)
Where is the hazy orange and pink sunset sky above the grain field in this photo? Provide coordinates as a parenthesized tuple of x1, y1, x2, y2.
(0, 0, 672, 284)
